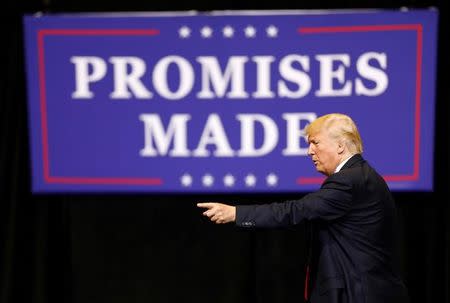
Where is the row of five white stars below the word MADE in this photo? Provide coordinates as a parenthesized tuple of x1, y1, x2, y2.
(180, 173, 278, 187)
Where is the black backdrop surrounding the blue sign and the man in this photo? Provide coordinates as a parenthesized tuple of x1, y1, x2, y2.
(0, 0, 450, 303)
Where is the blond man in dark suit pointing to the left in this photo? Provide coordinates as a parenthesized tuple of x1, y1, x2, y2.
(198, 114, 408, 303)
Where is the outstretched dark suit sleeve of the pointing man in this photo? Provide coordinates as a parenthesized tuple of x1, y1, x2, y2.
(236, 173, 352, 227)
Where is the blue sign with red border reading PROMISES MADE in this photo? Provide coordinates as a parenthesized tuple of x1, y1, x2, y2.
(24, 10, 437, 193)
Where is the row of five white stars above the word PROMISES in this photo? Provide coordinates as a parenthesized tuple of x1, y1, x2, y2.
(178, 25, 278, 39)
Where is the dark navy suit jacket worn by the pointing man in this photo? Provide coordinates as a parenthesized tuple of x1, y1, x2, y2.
(236, 154, 408, 303)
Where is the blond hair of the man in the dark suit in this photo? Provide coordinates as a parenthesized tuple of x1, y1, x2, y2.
(305, 113, 363, 154)
